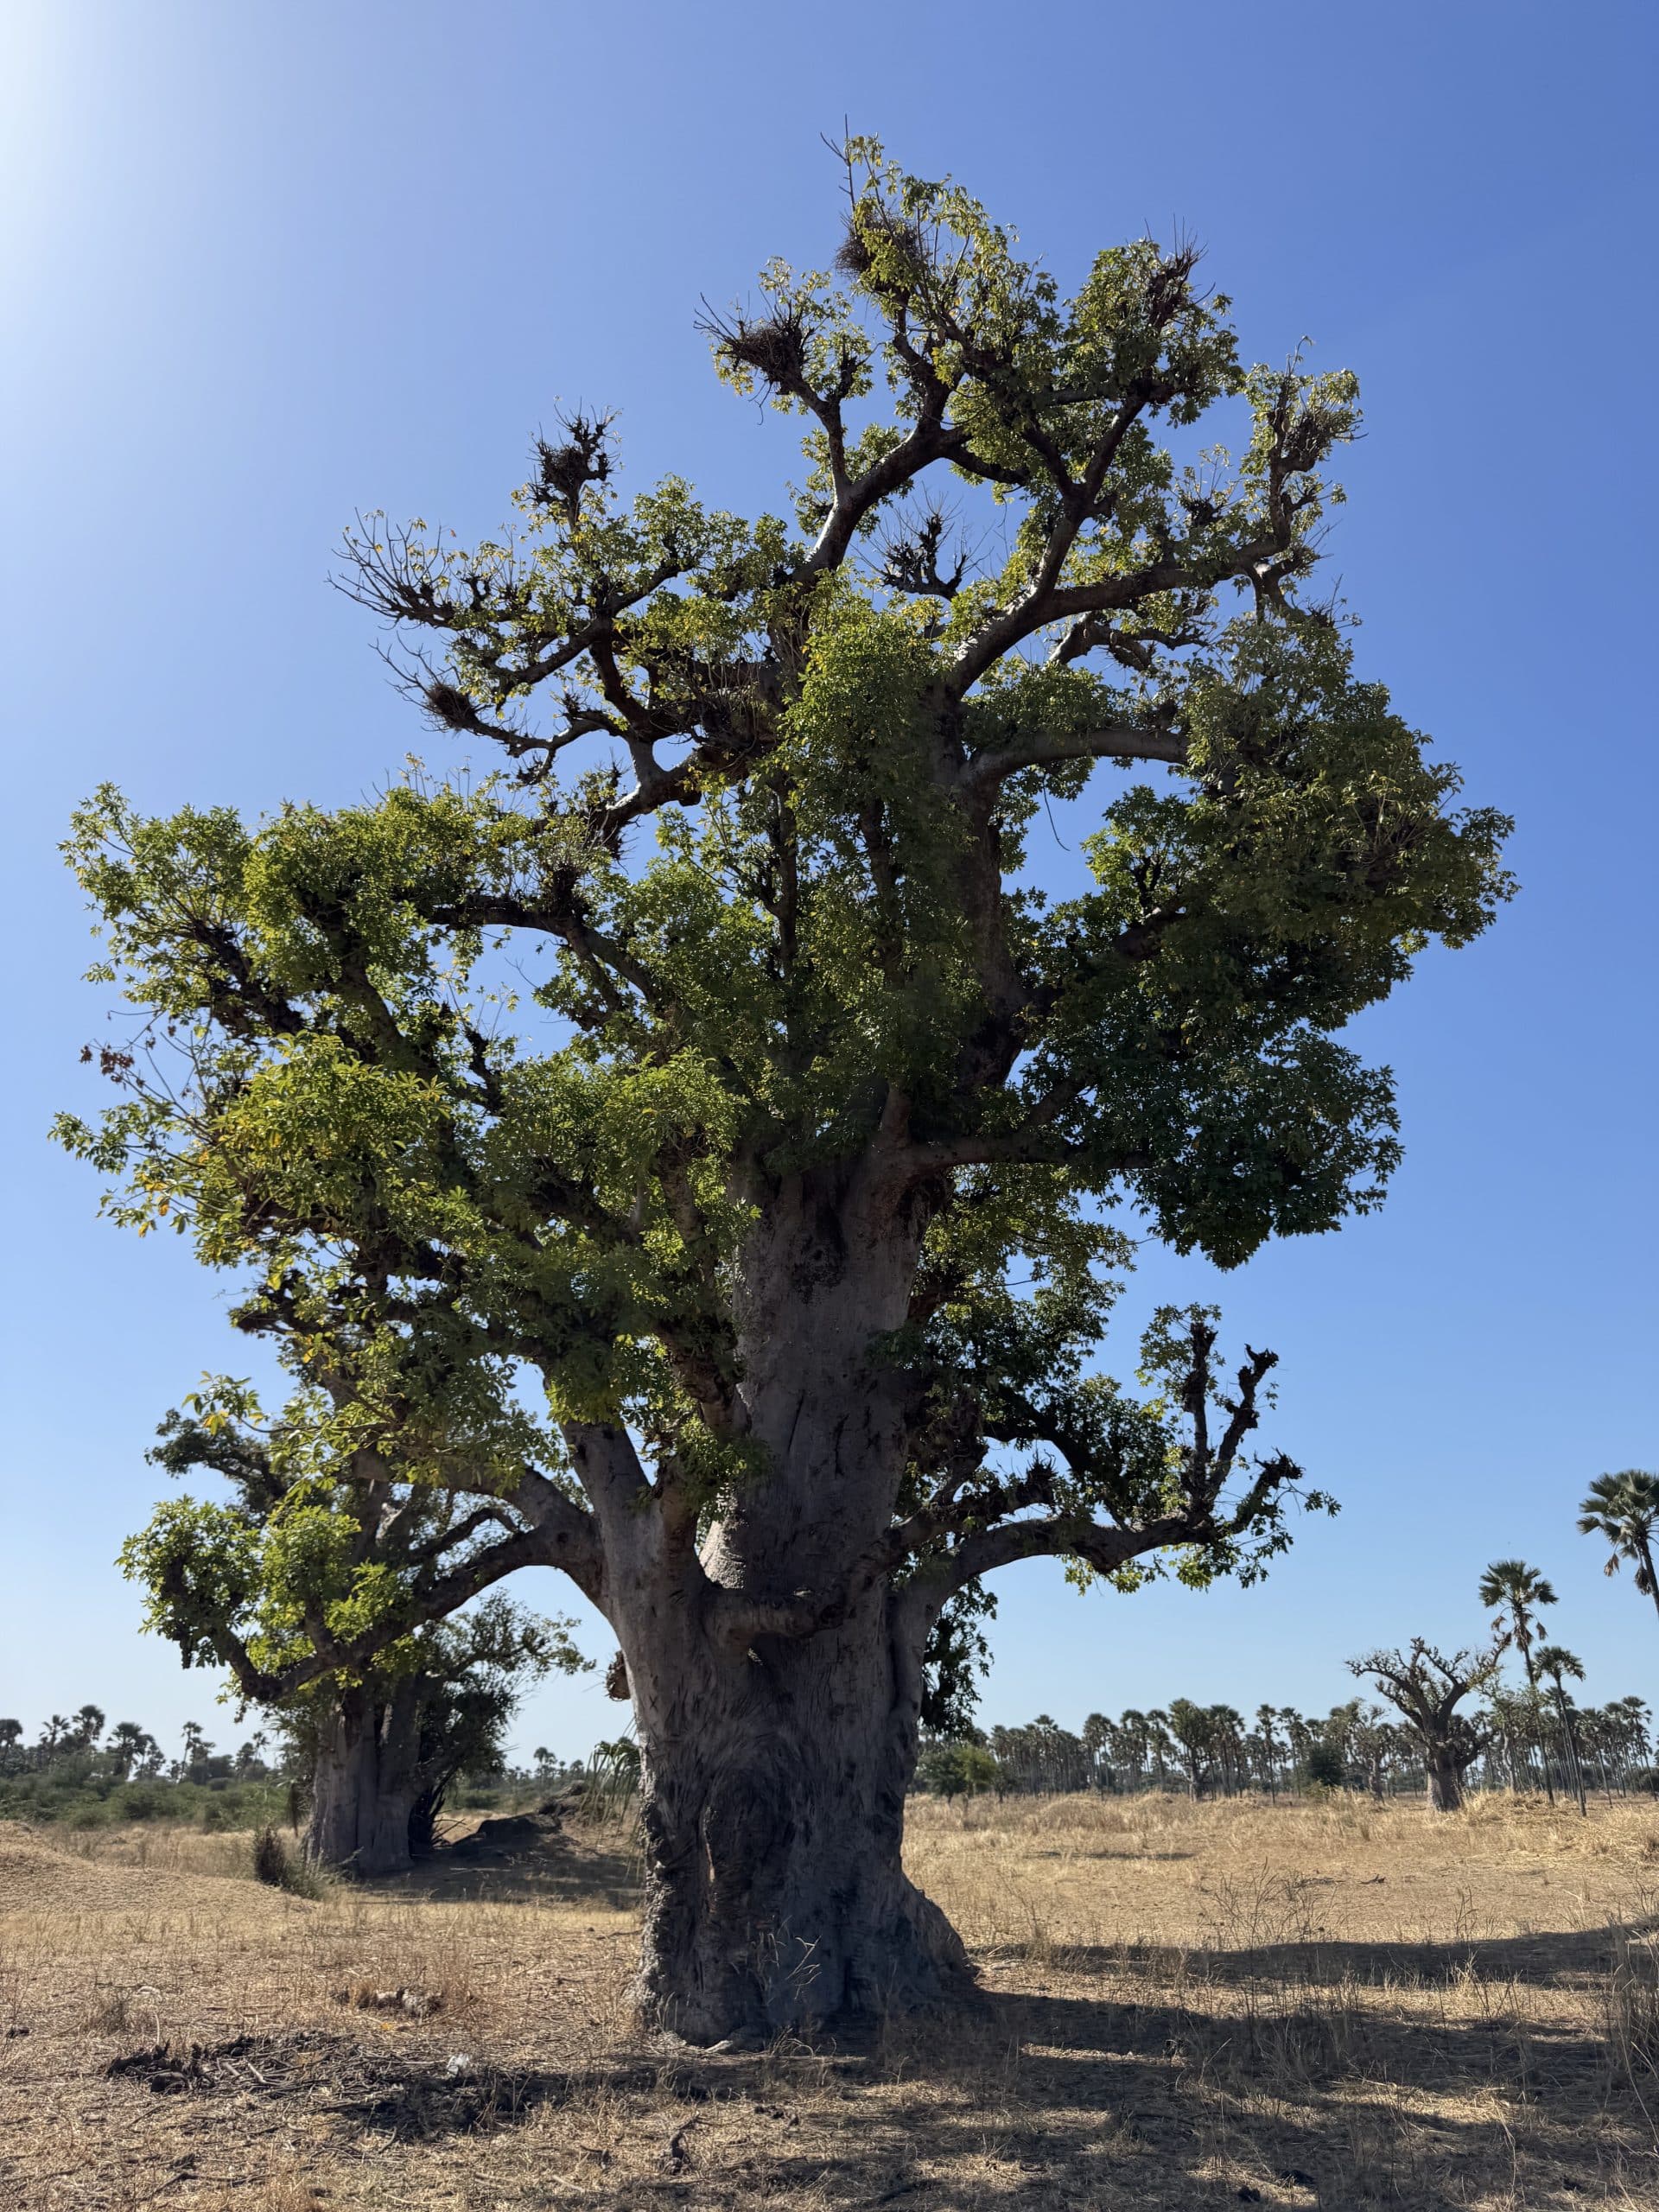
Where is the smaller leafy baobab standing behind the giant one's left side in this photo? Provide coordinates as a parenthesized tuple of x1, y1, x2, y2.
(122, 1371, 584, 1876)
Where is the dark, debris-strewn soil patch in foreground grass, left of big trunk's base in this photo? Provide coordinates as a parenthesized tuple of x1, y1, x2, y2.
(104, 2029, 734, 2141)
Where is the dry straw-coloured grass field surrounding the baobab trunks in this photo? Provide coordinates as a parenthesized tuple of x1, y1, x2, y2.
(0, 1798, 1659, 2212)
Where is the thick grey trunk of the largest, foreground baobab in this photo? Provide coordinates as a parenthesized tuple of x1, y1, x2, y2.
(606, 1174, 969, 2044)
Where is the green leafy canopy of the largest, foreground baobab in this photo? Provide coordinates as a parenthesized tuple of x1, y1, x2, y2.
(60, 139, 1510, 1643)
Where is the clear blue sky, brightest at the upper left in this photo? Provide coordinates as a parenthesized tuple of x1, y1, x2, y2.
(0, 0, 1659, 1754)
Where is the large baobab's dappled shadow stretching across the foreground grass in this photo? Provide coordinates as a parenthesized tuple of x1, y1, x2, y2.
(234, 1927, 1659, 2212)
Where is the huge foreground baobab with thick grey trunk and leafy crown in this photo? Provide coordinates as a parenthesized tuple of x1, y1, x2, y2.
(64, 142, 1509, 2042)
